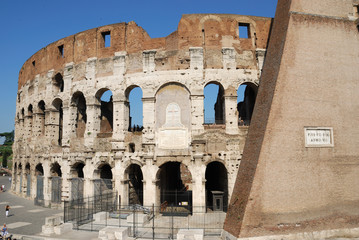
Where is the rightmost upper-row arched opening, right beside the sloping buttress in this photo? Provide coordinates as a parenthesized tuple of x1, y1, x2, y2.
(237, 83, 258, 126)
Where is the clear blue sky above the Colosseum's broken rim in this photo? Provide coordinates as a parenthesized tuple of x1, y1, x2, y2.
(0, 0, 277, 133)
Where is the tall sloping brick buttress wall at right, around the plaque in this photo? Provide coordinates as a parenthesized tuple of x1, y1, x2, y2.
(224, 0, 359, 239)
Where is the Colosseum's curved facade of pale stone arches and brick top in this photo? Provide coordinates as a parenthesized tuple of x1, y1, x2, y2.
(12, 14, 272, 211)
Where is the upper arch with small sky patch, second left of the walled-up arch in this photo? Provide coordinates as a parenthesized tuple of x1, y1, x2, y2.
(96, 88, 113, 133)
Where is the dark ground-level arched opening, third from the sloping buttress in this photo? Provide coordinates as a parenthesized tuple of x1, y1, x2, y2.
(125, 164, 143, 205)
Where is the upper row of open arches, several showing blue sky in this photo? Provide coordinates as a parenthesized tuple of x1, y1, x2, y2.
(17, 82, 257, 145)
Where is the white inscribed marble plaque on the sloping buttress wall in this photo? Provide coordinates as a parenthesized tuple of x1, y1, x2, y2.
(304, 127, 334, 147)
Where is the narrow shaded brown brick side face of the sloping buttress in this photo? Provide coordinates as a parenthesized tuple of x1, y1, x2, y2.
(224, 0, 290, 236)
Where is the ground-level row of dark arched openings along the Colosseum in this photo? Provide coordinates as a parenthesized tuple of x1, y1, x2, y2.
(14, 161, 228, 211)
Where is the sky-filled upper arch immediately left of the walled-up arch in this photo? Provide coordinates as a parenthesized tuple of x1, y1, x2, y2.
(126, 86, 143, 132)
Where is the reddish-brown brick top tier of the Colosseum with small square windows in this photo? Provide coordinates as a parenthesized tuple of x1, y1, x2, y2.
(18, 14, 272, 89)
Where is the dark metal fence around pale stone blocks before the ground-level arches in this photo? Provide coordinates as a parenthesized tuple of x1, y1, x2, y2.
(64, 198, 225, 239)
